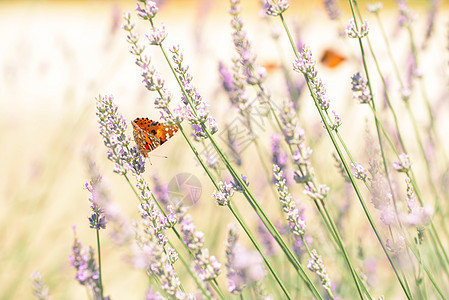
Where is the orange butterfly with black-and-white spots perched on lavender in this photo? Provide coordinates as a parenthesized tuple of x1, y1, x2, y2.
(131, 118, 179, 157)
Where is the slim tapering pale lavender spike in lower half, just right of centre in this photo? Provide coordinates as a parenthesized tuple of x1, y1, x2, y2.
(273, 165, 306, 239)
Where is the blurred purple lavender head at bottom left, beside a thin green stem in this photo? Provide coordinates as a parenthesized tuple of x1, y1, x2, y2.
(69, 231, 103, 299)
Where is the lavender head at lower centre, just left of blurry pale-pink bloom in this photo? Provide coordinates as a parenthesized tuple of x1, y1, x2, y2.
(179, 215, 221, 281)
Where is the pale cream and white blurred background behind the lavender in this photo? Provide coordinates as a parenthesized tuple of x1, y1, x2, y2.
(0, 0, 449, 299)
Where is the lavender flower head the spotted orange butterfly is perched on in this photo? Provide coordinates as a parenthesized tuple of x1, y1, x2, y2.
(97, 96, 145, 175)
